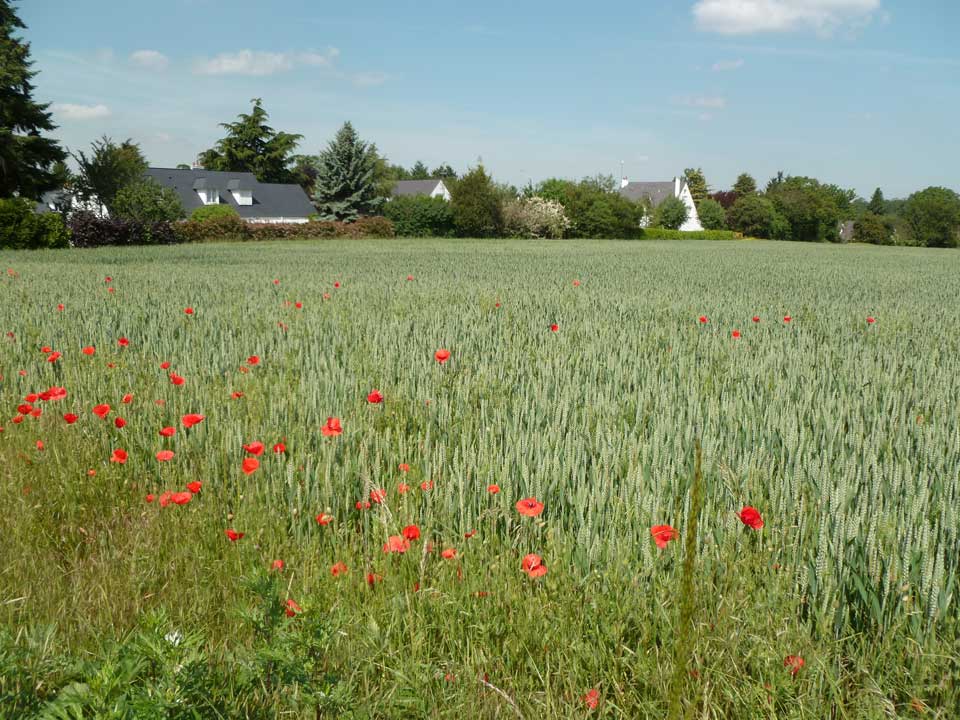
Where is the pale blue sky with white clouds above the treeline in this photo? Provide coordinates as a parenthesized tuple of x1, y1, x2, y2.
(19, 0, 960, 197)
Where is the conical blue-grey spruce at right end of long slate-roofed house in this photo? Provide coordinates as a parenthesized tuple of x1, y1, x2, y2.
(313, 122, 383, 222)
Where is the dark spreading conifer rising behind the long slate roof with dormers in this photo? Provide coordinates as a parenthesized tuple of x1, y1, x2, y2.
(199, 98, 303, 183)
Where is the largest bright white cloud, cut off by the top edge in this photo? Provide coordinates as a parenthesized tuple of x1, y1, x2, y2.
(693, 0, 880, 35)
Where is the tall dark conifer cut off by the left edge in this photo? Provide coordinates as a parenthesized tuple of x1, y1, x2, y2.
(0, 0, 67, 200)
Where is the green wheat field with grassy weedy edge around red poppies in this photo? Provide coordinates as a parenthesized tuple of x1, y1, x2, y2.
(0, 240, 960, 718)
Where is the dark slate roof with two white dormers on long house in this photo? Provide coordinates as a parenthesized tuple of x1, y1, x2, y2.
(147, 168, 316, 219)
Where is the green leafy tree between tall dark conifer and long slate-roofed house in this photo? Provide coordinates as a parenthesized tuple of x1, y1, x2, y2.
(73, 135, 147, 215)
